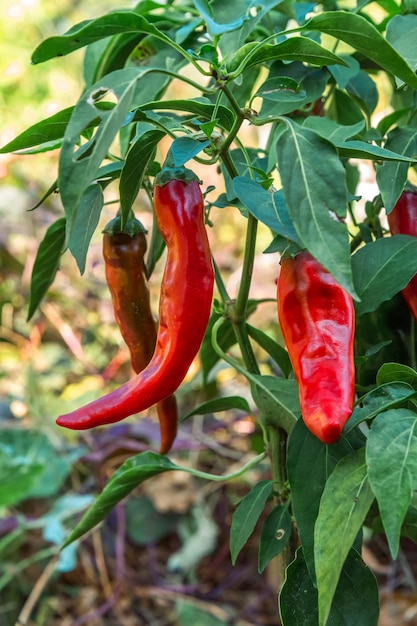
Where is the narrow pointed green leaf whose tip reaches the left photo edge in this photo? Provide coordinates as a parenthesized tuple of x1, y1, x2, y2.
(0, 107, 74, 154)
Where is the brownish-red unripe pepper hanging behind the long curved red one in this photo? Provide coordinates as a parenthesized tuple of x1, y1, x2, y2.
(103, 212, 178, 454)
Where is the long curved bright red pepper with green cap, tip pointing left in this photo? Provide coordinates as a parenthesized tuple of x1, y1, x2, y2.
(57, 161, 214, 446)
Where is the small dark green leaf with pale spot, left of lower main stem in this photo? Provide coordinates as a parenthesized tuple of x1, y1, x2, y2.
(258, 504, 292, 572)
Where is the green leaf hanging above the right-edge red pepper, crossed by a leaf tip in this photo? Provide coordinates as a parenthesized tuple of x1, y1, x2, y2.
(376, 126, 417, 213)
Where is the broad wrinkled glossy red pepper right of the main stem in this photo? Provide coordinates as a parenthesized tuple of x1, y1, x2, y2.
(277, 251, 355, 444)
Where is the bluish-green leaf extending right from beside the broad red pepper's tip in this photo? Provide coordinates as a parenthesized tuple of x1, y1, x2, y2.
(344, 380, 417, 433)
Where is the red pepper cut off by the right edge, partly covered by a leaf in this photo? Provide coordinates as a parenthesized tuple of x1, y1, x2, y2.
(388, 189, 417, 320)
